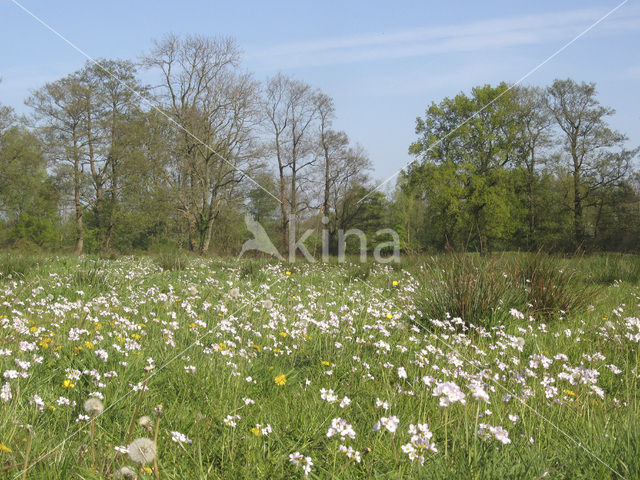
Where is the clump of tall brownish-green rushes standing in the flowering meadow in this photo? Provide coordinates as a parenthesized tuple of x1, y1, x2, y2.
(421, 253, 598, 324)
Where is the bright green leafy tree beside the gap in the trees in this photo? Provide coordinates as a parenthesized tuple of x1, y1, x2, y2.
(408, 83, 518, 252)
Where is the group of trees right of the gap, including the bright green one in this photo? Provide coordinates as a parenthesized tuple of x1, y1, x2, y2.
(397, 79, 640, 252)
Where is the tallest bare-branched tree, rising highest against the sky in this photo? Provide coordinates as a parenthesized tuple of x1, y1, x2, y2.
(143, 35, 258, 253)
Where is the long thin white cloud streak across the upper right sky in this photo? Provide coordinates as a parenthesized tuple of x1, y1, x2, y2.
(248, 9, 640, 69)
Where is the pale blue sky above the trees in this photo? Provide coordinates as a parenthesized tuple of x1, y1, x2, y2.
(0, 0, 640, 184)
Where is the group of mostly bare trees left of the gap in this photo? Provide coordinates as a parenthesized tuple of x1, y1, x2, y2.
(0, 35, 372, 253)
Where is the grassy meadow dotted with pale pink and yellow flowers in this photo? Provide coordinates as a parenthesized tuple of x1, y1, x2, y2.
(0, 255, 640, 479)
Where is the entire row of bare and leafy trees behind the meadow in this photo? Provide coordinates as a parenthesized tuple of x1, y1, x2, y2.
(0, 35, 640, 254)
